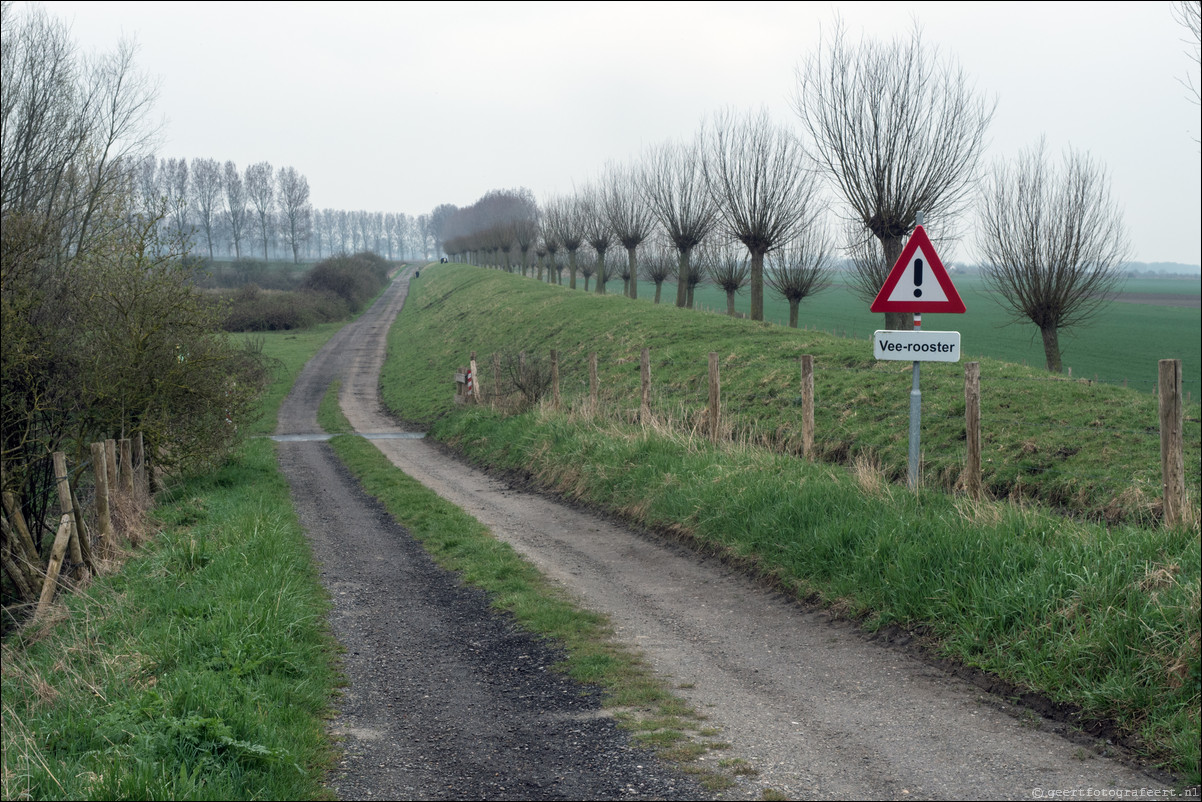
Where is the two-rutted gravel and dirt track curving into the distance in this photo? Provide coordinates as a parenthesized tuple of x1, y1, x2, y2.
(279, 269, 1166, 800)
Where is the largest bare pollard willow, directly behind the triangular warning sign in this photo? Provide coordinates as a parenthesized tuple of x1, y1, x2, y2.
(795, 25, 995, 328)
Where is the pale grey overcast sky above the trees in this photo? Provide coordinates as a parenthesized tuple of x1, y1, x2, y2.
(43, 2, 1202, 265)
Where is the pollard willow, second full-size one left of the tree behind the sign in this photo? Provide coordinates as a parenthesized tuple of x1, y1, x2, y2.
(639, 141, 718, 308)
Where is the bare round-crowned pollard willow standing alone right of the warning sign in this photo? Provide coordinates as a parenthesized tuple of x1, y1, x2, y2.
(977, 141, 1129, 373)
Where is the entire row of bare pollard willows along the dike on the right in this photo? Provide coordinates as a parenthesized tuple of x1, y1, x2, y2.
(435, 25, 1144, 370)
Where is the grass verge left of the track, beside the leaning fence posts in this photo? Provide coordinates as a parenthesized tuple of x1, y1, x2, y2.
(0, 325, 348, 800)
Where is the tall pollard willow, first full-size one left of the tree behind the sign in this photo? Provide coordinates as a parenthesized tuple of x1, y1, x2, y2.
(703, 111, 819, 320)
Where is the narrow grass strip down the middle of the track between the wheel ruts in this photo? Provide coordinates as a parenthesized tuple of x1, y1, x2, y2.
(317, 385, 746, 790)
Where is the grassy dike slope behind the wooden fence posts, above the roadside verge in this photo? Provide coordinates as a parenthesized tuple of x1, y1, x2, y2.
(382, 266, 1202, 522)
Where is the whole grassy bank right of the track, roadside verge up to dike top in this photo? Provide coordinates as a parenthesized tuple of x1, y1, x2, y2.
(382, 266, 1200, 782)
